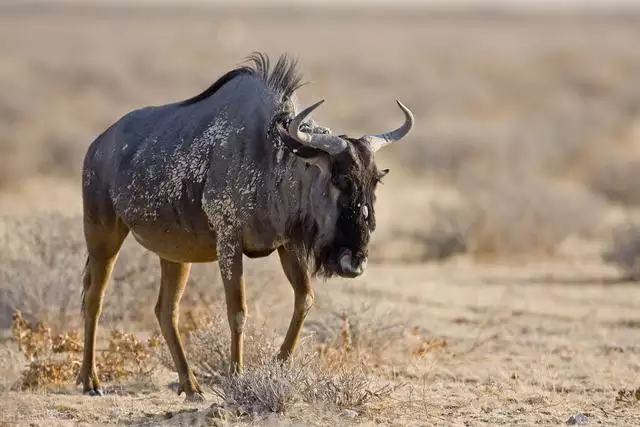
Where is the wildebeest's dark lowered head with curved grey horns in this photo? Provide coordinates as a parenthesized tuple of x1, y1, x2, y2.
(281, 101, 414, 277)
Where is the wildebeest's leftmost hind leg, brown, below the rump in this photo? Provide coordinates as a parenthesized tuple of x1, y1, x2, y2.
(76, 221, 129, 396)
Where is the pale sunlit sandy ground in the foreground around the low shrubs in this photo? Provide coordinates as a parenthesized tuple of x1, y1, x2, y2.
(2, 261, 640, 425)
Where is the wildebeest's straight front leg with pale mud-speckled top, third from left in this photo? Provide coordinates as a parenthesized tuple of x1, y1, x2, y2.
(217, 234, 247, 373)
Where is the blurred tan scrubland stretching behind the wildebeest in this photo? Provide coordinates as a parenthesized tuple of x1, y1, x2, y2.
(0, 1, 640, 319)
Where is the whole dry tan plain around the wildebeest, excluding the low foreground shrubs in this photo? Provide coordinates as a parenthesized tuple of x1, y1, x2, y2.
(0, 1, 640, 426)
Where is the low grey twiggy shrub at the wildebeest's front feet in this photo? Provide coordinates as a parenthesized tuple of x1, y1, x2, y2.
(156, 309, 396, 417)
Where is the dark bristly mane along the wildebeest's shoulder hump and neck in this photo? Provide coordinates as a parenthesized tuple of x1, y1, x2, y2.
(180, 52, 305, 105)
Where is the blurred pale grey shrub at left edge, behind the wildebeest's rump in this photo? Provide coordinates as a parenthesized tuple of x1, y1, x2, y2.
(0, 213, 84, 327)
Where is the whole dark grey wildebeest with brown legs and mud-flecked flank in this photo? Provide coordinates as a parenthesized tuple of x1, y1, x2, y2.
(78, 53, 414, 400)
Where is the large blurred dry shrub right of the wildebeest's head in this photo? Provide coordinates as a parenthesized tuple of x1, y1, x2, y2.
(422, 175, 606, 258)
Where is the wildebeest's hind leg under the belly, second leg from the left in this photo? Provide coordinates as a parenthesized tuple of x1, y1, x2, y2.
(155, 258, 204, 402)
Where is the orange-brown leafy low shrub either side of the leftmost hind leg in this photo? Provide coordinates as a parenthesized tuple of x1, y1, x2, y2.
(11, 312, 158, 390)
